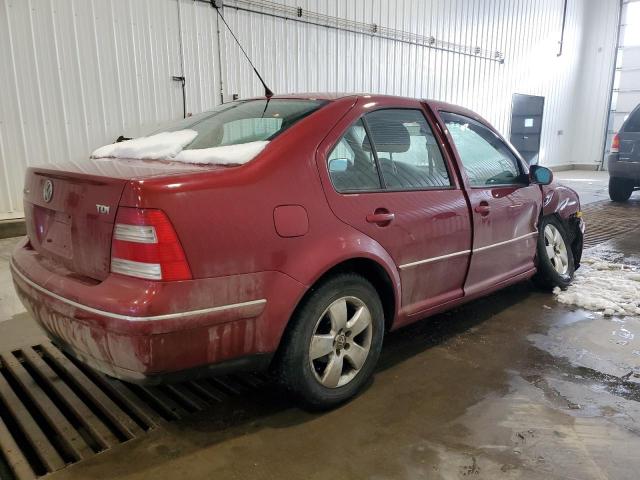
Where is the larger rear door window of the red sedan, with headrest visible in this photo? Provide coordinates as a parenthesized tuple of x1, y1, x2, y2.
(364, 109, 451, 190)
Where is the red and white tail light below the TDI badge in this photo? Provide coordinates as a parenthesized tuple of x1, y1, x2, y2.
(111, 207, 192, 281)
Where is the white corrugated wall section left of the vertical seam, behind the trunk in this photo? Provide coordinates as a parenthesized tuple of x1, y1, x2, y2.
(0, 0, 220, 218)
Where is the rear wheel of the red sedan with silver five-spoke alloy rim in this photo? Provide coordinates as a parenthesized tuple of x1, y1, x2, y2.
(277, 274, 384, 410)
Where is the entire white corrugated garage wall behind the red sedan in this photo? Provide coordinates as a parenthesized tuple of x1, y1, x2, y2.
(0, 0, 619, 218)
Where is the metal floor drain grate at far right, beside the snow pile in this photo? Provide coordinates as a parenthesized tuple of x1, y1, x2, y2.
(582, 200, 640, 247)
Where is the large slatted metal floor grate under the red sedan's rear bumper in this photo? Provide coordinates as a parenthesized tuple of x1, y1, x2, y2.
(0, 342, 265, 480)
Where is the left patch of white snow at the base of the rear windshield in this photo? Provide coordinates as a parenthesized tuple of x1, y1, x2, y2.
(91, 130, 198, 160)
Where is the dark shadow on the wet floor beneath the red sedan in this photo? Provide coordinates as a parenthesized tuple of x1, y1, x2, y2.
(70, 282, 548, 480)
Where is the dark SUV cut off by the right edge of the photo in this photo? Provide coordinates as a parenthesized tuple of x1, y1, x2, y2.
(609, 105, 640, 202)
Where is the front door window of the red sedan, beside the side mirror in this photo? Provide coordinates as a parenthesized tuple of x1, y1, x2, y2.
(441, 113, 522, 186)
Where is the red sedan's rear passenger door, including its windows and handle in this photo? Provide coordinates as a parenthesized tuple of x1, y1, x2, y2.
(317, 99, 471, 322)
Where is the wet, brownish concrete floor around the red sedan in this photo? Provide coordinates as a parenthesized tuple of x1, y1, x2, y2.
(0, 172, 640, 480)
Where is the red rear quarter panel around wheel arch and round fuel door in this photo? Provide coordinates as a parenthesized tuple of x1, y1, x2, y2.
(115, 97, 410, 350)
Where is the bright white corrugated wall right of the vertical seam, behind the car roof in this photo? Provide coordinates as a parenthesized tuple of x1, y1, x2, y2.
(223, 0, 618, 172)
